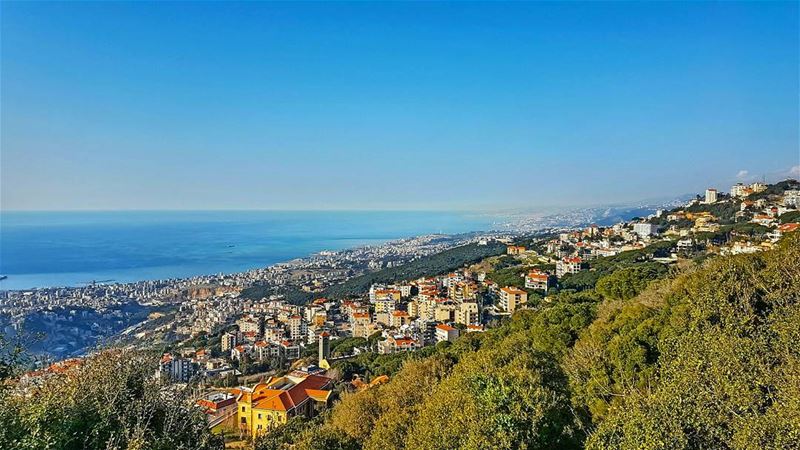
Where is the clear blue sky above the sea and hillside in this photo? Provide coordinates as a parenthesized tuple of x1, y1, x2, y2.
(0, 1, 800, 210)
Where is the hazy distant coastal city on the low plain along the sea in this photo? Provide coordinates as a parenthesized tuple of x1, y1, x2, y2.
(0, 233, 505, 359)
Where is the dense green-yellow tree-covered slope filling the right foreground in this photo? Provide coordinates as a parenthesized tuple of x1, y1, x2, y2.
(274, 235, 800, 449)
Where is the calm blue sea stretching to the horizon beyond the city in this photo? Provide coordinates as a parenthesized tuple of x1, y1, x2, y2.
(0, 211, 494, 290)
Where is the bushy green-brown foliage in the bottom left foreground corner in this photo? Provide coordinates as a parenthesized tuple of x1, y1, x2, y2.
(0, 350, 223, 450)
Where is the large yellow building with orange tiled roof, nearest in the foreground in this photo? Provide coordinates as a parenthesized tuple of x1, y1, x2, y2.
(233, 375, 333, 436)
